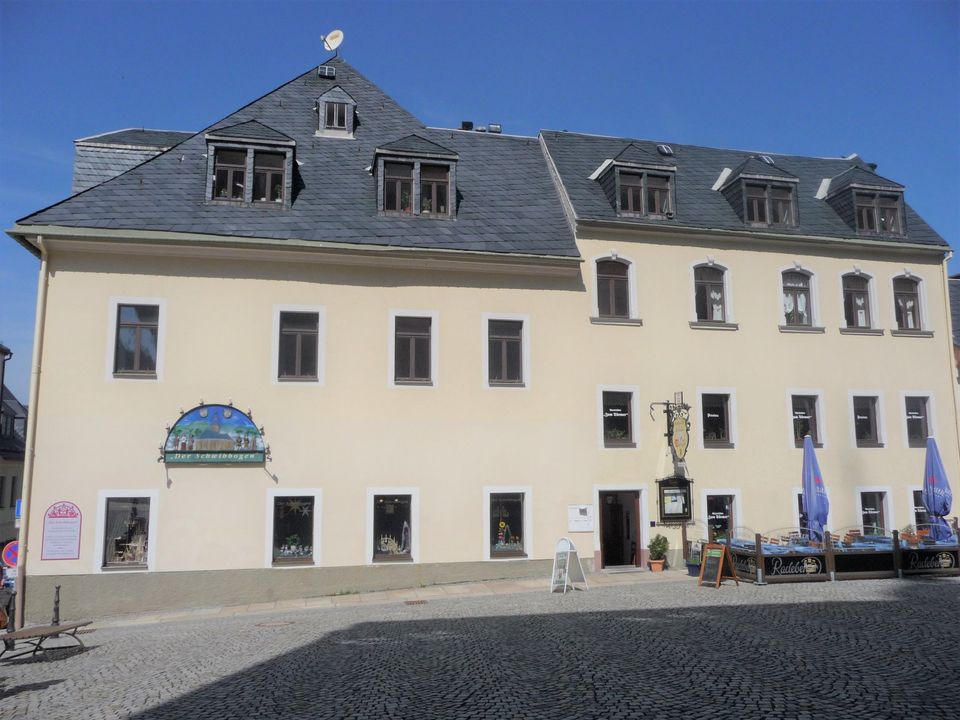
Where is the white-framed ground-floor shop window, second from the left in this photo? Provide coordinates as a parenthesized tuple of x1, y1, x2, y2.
(263, 488, 323, 568)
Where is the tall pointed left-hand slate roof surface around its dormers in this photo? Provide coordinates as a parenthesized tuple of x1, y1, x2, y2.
(19, 57, 578, 257)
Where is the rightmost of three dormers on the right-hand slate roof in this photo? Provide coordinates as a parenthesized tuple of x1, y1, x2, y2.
(818, 165, 906, 237)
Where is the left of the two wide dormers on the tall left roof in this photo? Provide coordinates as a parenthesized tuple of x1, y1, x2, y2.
(205, 120, 297, 209)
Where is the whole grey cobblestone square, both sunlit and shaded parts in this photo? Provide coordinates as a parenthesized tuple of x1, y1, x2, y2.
(0, 574, 960, 720)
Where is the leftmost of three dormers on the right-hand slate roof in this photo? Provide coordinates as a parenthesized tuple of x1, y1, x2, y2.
(590, 143, 677, 219)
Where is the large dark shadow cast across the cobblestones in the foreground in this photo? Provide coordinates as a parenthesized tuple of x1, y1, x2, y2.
(125, 581, 960, 720)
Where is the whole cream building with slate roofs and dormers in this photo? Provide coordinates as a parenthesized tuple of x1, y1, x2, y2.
(9, 58, 960, 619)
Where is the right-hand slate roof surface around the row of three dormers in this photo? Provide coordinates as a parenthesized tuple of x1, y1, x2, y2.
(541, 130, 947, 246)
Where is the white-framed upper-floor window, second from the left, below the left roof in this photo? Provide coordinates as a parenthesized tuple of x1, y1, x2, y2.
(270, 305, 327, 386)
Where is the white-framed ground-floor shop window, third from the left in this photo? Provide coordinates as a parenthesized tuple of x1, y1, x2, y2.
(364, 486, 420, 565)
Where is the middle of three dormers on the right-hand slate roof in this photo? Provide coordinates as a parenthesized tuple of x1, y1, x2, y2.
(717, 155, 800, 227)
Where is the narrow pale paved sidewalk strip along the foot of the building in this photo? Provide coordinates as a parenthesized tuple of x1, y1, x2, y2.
(93, 570, 660, 628)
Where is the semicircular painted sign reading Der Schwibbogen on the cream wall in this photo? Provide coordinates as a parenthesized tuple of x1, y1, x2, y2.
(161, 401, 270, 465)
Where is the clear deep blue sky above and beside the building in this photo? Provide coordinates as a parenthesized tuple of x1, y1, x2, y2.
(0, 0, 960, 401)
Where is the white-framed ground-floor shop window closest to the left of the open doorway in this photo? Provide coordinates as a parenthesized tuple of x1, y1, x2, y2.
(482, 485, 533, 560)
